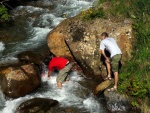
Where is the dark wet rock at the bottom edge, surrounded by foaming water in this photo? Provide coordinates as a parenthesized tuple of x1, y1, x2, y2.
(15, 98, 58, 113)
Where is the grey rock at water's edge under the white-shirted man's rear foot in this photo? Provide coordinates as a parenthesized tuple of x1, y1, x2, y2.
(104, 90, 131, 112)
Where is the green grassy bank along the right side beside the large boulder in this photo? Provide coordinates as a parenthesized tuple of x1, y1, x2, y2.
(82, 0, 150, 105)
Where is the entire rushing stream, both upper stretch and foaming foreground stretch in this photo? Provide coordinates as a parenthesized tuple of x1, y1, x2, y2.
(0, 0, 111, 113)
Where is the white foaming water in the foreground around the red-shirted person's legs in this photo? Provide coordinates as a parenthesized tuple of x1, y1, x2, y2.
(2, 73, 104, 113)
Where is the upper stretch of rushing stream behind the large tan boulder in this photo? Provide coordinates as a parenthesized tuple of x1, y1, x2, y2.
(0, 0, 94, 64)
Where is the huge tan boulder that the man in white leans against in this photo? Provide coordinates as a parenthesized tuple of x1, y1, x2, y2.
(47, 15, 134, 78)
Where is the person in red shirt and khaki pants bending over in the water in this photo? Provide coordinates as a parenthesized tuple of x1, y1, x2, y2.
(48, 57, 72, 88)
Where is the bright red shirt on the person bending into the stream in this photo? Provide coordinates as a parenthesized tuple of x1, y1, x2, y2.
(48, 57, 69, 71)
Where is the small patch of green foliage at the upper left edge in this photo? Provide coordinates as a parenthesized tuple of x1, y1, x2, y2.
(0, 5, 9, 21)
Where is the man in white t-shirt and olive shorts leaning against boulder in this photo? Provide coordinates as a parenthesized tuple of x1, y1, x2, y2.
(100, 32, 122, 91)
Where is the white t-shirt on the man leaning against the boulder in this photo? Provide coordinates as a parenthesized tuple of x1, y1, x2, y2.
(100, 38, 122, 58)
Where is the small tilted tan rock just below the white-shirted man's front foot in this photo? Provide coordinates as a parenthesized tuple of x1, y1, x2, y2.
(95, 79, 114, 95)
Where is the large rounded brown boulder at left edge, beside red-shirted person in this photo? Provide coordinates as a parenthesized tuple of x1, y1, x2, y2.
(0, 64, 41, 98)
